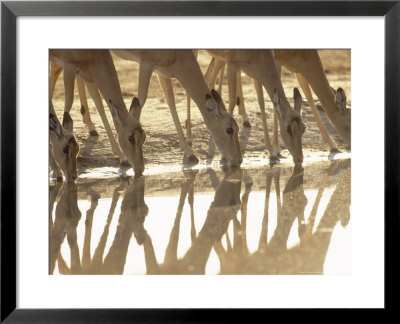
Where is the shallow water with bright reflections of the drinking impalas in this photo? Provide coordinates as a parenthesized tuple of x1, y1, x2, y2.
(49, 157, 352, 275)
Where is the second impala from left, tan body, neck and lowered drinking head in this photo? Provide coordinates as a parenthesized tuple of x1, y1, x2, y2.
(50, 50, 146, 175)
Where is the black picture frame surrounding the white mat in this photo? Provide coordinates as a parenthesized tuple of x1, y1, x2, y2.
(1, 0, 400, 323)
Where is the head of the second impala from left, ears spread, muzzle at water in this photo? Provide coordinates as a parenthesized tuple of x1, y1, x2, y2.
(108, 97, 146, 176)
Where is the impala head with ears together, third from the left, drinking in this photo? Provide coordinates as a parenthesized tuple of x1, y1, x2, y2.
(206, 90, 242, 166)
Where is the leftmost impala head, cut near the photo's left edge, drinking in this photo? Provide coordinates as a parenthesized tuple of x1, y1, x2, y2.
(49, 113, 79, 182)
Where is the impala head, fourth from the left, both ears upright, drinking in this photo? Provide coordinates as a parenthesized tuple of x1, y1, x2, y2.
(274, 88, 306, 165)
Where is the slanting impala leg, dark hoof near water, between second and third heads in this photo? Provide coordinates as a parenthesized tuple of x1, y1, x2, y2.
(158, 74, 199, 163)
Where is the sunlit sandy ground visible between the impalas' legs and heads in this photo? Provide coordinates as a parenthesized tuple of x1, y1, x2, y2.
(53, 50, 351, 178)
